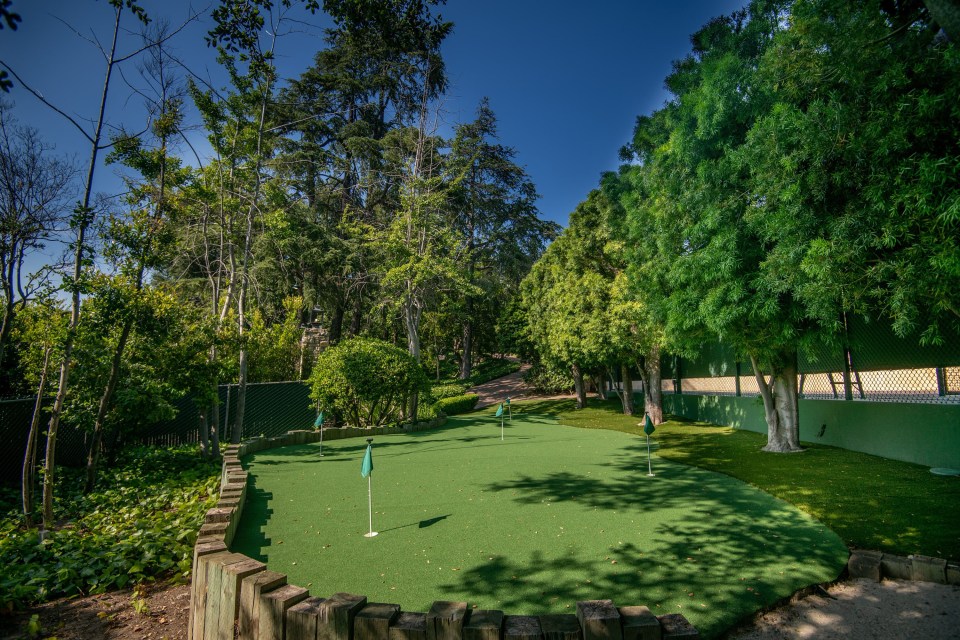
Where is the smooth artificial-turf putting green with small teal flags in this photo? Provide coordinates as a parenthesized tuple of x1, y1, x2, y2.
(233, 412, 847, 637)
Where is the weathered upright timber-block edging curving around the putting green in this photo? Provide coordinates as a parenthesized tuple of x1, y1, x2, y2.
(187, 418, 700, 640)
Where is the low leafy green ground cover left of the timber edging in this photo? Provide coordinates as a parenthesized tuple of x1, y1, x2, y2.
(0, 447, 219, 611)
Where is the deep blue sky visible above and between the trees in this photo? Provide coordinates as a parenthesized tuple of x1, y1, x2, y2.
(0, 0, 745, 235)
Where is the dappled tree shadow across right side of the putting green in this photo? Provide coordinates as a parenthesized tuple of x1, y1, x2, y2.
(480, 446, 847, 637)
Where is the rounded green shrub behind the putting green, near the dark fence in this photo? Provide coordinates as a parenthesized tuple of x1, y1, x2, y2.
(309, 338, 428, 427)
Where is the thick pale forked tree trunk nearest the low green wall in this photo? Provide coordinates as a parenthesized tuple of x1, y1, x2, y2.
(750, 353, 803, 453)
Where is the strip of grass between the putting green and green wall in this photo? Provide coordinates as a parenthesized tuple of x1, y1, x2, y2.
(517, 399, 960, 560)
